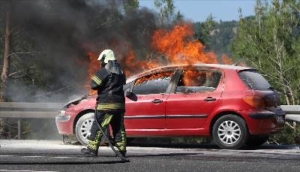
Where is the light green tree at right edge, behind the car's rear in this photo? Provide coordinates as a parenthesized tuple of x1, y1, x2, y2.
(231, 0, 300, 104)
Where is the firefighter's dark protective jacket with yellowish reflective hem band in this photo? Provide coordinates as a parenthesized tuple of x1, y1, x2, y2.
(90, 60, 126, 113)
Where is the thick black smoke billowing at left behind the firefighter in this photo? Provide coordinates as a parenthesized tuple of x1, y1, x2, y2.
(0, 0, 157, 101)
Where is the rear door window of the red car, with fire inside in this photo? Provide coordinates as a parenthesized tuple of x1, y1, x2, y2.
(176, 68, 221, 93)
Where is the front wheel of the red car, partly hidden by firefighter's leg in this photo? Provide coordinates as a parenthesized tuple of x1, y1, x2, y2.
(75, 112, 95, 145)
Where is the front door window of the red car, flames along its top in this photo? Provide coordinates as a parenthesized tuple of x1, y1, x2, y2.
(132, 72, 173, 94)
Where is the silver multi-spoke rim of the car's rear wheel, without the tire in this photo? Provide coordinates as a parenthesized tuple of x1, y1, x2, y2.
(218, 120, 242, 145)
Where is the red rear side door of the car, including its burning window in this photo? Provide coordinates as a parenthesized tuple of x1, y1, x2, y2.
(166, 68, 222, 129)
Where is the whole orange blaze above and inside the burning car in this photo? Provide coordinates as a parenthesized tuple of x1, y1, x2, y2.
(87, 23, 227, 94)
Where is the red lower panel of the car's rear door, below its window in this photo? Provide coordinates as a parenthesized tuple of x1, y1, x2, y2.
(166, 90, 222, 129)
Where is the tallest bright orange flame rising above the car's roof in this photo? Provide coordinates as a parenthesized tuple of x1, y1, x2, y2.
(152, 24, 217, 64)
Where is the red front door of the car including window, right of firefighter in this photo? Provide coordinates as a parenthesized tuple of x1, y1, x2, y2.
(125, 72, 173, 132)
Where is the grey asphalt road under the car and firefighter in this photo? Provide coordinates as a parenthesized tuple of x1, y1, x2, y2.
(0, 140, 300, 172)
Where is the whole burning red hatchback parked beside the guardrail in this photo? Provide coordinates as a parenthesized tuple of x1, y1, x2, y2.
(56, 64, 285, 149)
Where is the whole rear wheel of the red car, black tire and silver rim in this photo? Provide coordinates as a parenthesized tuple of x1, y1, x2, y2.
(212, 114, 248, 149)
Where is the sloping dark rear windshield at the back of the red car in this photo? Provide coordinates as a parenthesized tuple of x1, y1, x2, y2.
(239, 70, 271, 90)
